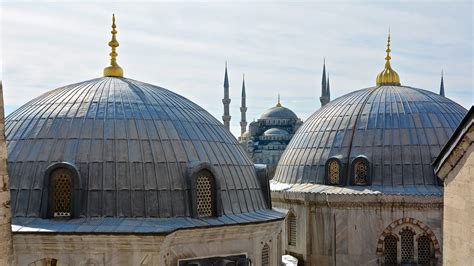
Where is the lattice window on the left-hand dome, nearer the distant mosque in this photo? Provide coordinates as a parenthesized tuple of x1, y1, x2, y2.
(196, 171, 215, 217)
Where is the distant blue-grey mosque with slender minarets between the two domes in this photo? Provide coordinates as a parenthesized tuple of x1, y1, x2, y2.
(222, 62, 331, 178)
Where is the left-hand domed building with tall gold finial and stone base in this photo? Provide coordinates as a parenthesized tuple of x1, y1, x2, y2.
(0, 15, 286, 266)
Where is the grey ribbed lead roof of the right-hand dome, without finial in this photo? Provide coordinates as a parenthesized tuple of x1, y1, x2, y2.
(272, 86, 467, 193)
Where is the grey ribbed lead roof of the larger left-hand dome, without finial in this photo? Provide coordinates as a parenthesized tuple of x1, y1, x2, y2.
(6, 77, 267, 218)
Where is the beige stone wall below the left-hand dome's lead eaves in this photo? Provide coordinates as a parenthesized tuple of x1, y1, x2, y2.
(13, 221, 283, 266)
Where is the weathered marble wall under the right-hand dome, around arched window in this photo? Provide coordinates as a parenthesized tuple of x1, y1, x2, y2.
(272, 192, 443, 265)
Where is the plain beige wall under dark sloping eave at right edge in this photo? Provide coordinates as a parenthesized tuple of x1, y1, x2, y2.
(443, 143, 474, 265)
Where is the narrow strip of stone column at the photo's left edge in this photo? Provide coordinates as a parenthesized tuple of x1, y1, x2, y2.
(0, 81, 13, 265)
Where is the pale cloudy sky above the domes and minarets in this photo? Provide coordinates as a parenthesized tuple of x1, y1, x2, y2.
(0, 1, 474, 137)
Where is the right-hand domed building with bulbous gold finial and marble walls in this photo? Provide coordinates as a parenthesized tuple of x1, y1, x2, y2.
(270, 32, 467, 265)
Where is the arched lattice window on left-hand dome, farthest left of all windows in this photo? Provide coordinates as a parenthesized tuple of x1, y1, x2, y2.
(51, 169, 72, 218)
